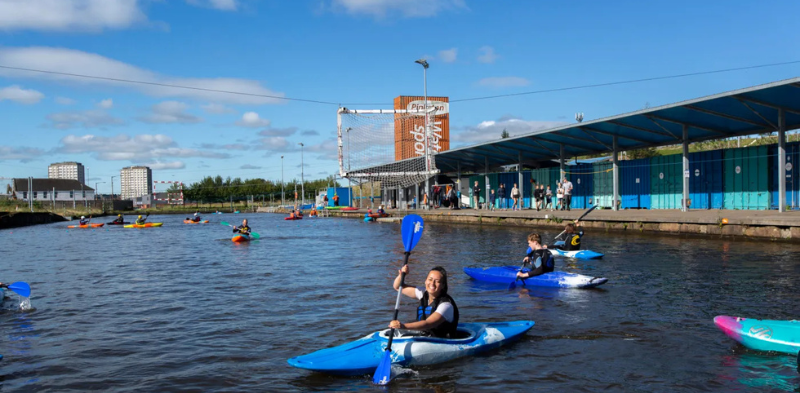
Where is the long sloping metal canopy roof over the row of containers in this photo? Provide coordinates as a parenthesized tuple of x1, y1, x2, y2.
(435, 77, 800, 173)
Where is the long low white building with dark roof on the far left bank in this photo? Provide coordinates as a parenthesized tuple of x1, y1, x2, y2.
(11, 179, 94, 201)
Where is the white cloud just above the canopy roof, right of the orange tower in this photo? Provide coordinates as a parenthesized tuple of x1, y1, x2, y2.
(450, 117, 568, 146)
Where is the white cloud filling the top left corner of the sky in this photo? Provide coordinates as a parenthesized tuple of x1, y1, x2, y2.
(0, 0, 147, 33)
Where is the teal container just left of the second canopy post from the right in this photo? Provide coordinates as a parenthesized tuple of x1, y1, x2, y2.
(650, 154, 683, 209)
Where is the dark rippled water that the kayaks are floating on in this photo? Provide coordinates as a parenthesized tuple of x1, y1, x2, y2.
(0, 214, 800, 392)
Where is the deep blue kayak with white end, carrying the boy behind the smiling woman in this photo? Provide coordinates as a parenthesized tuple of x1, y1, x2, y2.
(464, 266, 608, 288)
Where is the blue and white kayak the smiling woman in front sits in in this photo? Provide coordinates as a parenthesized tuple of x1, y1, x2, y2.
(288, 321, 533, 375)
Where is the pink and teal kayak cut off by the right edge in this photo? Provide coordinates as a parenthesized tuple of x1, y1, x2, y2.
(714, 315, 800, 355)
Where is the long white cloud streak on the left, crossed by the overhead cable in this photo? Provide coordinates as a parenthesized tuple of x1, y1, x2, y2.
(0, 46, 284, 105)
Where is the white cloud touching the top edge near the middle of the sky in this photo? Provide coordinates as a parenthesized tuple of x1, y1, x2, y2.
(331, 0, 466, 18)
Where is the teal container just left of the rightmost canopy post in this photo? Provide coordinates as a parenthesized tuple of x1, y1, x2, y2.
(723, 146, 770, 210)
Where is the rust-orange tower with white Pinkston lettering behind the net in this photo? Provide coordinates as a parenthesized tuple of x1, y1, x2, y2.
(394, 96, 450, 161)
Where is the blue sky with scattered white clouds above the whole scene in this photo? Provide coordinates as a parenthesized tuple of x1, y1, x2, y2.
(0, 0, 800, 193)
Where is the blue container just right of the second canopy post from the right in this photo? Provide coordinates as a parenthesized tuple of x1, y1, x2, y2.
(681, 150, 725, 209)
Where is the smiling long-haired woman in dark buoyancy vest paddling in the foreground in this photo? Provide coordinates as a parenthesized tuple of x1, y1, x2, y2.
(389, 265, 458, 338)
